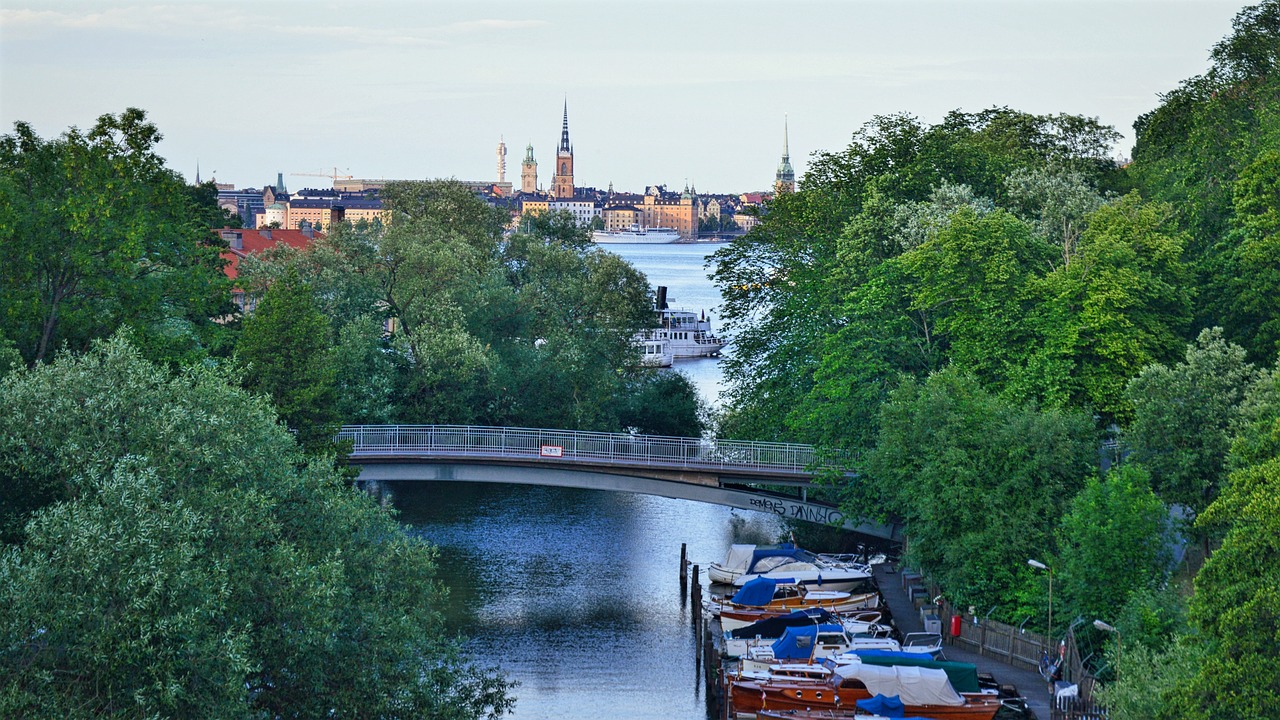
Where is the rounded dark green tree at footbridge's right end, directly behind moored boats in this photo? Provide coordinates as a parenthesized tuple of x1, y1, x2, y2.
(860, 370, 1094, 607)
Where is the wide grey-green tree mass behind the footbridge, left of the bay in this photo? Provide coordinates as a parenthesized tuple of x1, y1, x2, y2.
(242, 182, 703, 436)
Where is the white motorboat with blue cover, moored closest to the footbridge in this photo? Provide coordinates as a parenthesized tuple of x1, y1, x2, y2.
(708, 543, 874, 593)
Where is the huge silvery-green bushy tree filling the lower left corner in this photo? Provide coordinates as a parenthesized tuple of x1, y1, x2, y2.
(0, 338, 511, 719)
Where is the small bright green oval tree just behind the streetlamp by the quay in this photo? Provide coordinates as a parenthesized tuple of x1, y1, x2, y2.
(1057, 462, 1169, 620)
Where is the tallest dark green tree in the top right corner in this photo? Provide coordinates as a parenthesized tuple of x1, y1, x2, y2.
(1129, 0, 1280, 348)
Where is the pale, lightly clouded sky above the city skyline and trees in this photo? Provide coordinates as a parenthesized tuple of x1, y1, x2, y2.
(0, 0, 1244, 193)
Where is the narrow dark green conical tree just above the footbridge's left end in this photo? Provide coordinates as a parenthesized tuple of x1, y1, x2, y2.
(237, 270, 337, 443)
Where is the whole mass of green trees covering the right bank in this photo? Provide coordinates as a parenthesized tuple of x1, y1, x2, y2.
(714, 0, 1280, 717)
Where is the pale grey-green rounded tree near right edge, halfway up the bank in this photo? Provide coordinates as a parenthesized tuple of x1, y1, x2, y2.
(1124, 328, 1258, 525)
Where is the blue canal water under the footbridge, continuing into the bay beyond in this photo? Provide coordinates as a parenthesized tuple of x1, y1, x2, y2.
(389, 245, 783, 720)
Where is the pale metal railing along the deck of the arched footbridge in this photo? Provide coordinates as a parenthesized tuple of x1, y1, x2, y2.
(338, 425, 815, 474)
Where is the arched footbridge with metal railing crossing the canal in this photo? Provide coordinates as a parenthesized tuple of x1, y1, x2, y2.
(338, 425, 899, 539)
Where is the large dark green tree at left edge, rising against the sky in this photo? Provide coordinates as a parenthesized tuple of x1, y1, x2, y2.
(0, 108, 230, 363)
